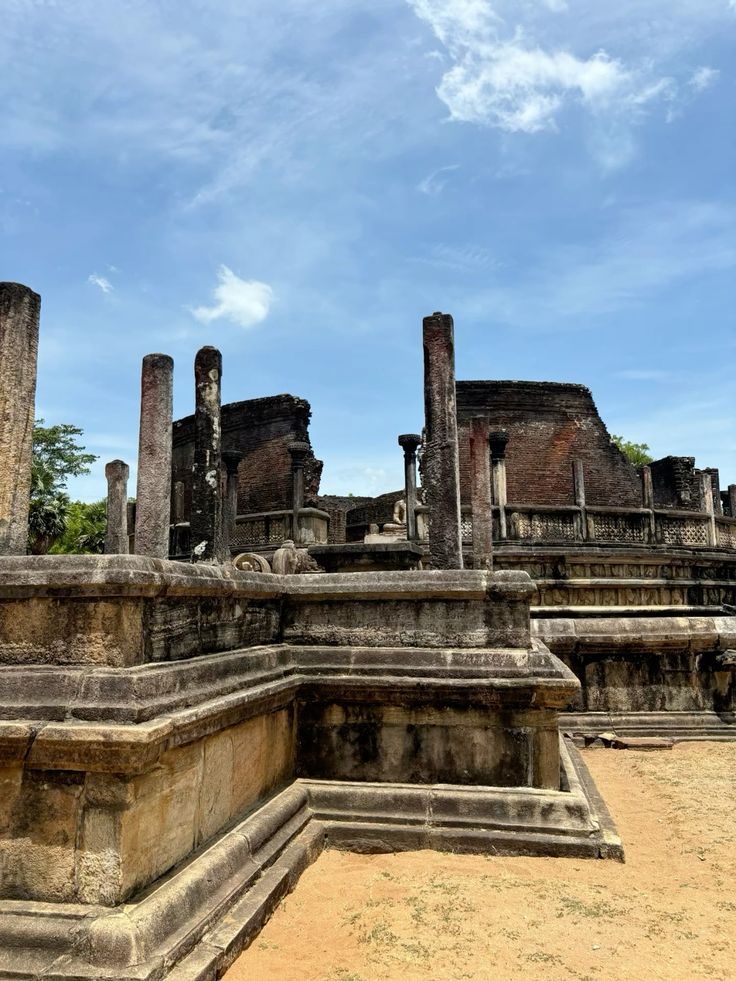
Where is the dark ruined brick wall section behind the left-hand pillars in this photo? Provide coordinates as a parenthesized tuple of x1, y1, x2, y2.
(172, 395, 322, 520)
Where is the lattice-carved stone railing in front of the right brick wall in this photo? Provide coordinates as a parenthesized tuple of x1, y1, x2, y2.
(417, 504, 736, 549)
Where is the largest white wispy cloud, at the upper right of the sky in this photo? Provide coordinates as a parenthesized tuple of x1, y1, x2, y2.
(407, 0, 720, 168)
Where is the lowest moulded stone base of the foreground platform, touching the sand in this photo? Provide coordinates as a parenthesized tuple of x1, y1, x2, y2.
(0, 744, 623, 981)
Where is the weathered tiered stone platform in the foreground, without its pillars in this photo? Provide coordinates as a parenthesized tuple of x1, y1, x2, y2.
(0, 556, 621, 979)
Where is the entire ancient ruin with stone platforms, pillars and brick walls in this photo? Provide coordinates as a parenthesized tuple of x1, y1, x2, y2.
(0, 284, 736, 981)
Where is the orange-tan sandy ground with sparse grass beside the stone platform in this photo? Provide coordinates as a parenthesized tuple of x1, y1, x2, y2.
(225, 743, 736, 981)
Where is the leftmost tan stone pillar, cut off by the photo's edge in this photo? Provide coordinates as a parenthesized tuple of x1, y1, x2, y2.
(0, 283, 41, 555)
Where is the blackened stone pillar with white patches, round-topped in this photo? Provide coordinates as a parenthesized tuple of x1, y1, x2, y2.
(190, 347, 225, 562)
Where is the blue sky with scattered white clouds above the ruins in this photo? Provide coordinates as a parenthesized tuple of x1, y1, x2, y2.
(0, 0, 736, 500)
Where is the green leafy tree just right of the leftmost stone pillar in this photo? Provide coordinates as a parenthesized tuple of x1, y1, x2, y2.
(28, 419, 98, 555)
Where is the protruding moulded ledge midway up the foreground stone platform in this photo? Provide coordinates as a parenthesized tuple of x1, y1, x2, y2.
(0, 642, 580, 774)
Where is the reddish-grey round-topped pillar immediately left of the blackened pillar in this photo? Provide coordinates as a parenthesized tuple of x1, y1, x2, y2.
(135, 354, 174, 559)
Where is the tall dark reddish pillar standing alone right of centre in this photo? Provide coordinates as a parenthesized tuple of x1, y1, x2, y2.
(422, 312, 463, 569)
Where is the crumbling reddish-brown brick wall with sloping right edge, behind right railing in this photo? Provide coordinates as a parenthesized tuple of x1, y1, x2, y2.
(457, 381, 642, 507)
